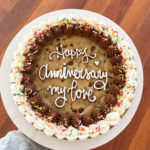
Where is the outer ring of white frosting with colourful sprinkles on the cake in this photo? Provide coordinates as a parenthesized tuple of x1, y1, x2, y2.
(10, 15, 137, 140)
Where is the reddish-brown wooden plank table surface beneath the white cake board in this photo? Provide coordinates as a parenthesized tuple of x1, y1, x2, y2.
(0, 0, 150, 150)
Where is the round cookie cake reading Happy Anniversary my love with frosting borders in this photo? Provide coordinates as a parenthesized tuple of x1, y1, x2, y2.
(10, 16, 137, 140)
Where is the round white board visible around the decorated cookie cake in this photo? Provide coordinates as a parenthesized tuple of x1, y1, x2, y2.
(0, 9, 143, 150)
